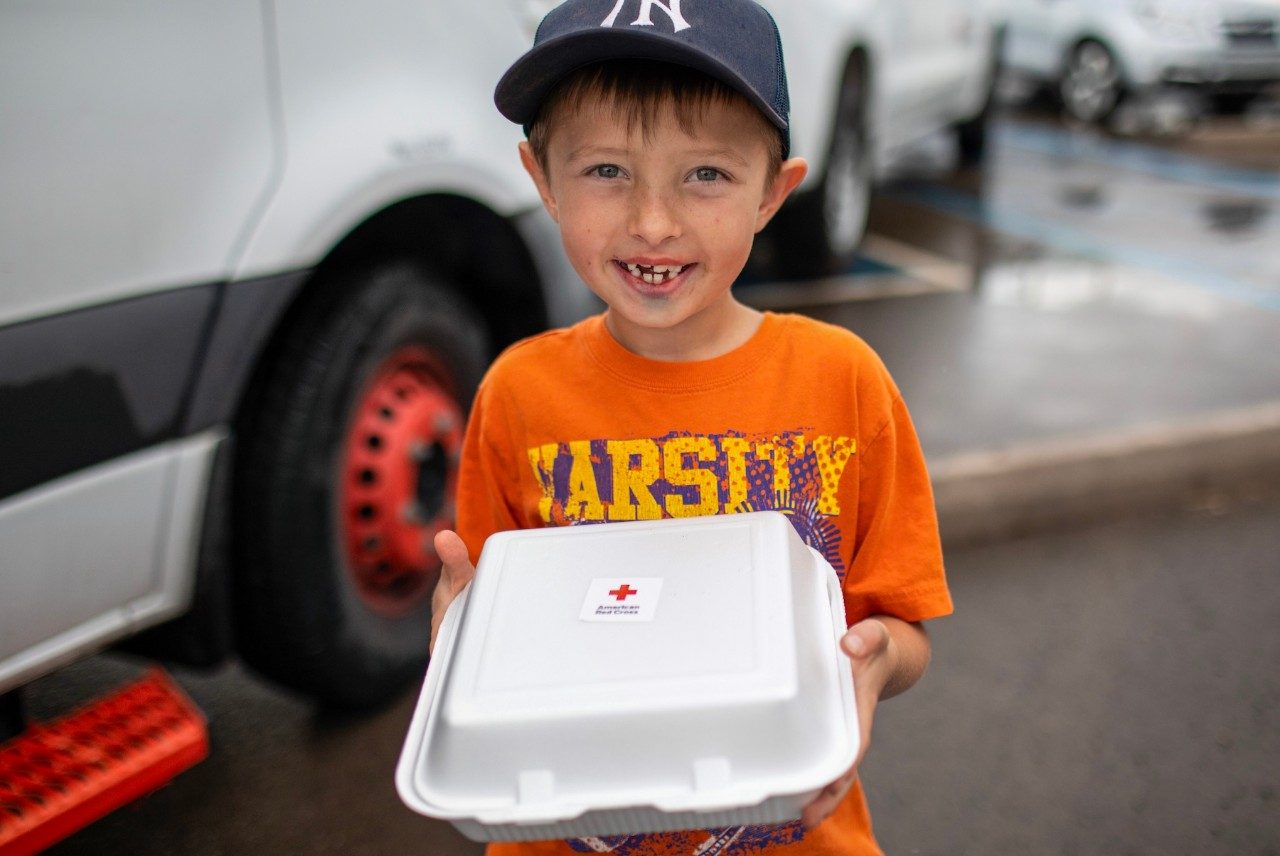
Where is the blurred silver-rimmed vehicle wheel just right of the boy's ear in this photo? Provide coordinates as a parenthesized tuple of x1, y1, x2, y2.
(771, 58, 872, 279)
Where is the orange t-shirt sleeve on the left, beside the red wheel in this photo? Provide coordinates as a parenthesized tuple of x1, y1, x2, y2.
(457, 381, 521, 562)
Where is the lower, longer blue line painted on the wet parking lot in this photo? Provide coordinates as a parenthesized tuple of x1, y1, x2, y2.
(886, 184, 1280, 312)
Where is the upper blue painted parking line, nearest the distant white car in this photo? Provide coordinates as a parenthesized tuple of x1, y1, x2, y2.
(996, 122, 1280, 200)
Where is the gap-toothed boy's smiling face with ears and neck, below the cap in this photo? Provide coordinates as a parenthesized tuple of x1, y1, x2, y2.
(521, 87, 806, 358)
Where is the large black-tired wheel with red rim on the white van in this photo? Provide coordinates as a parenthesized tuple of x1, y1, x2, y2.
(233, 265, 488, 708)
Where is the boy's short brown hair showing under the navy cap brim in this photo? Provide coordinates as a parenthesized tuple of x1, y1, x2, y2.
(527, 60, 786, 186)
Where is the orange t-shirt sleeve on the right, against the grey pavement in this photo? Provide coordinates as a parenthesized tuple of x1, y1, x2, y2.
(845, 391, 951, 623)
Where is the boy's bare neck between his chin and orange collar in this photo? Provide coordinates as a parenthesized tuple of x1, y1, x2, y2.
(604, 299, 764, 362)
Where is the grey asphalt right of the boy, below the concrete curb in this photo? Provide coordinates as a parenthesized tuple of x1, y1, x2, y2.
(863, 491, 1280, 856)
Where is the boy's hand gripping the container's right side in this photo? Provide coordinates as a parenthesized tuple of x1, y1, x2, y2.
(800, 618, 897, 829)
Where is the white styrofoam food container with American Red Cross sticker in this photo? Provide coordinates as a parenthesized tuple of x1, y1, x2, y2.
(396, 512, 858, 841)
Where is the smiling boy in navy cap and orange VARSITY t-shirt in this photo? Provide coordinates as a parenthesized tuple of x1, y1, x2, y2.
(433, 0, 951, 856)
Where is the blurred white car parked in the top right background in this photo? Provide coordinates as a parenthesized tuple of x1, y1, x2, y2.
(1002, 0, 1280, 122)
